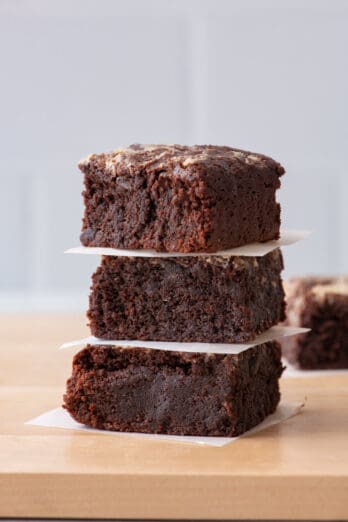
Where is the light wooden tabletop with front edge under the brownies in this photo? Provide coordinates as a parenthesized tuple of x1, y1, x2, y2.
(0, 315, 348, 520)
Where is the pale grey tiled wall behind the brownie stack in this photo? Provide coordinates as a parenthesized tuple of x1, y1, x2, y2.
(0, 0, 348, 309)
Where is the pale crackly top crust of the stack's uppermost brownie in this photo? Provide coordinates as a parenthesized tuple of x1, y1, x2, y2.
(78, 144, 285, 176)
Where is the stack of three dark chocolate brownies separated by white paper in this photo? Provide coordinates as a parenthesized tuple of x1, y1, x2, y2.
(64, 145, 284, 436)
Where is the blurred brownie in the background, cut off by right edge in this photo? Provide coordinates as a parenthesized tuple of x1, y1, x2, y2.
(281, 277, 348, 370)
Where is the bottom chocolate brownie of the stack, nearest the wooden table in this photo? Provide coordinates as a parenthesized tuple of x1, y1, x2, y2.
(64, 342, 283, 437)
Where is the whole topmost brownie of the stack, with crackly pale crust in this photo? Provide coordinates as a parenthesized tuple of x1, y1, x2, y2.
(79, 145, 284, 252)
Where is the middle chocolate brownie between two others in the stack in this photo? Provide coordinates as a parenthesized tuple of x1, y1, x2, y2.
(88, 250, 285, 343)
